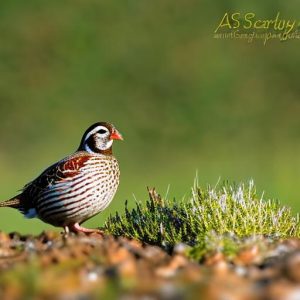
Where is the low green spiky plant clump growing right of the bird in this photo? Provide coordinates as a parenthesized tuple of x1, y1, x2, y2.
(104, 180, 300, 260)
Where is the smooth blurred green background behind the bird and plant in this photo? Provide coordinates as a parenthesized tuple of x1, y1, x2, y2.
(0, 0, 300, 233)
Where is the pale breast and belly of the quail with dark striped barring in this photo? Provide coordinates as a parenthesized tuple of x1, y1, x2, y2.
(35, 154, 119, 226)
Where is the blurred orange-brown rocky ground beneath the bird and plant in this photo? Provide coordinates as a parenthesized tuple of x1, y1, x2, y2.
(0, 232, 300, 300)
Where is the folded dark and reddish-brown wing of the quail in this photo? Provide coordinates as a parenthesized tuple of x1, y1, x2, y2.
(17, 154, 90, 213)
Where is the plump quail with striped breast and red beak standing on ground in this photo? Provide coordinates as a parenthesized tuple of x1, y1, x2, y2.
(0, 122, 123, 233)
